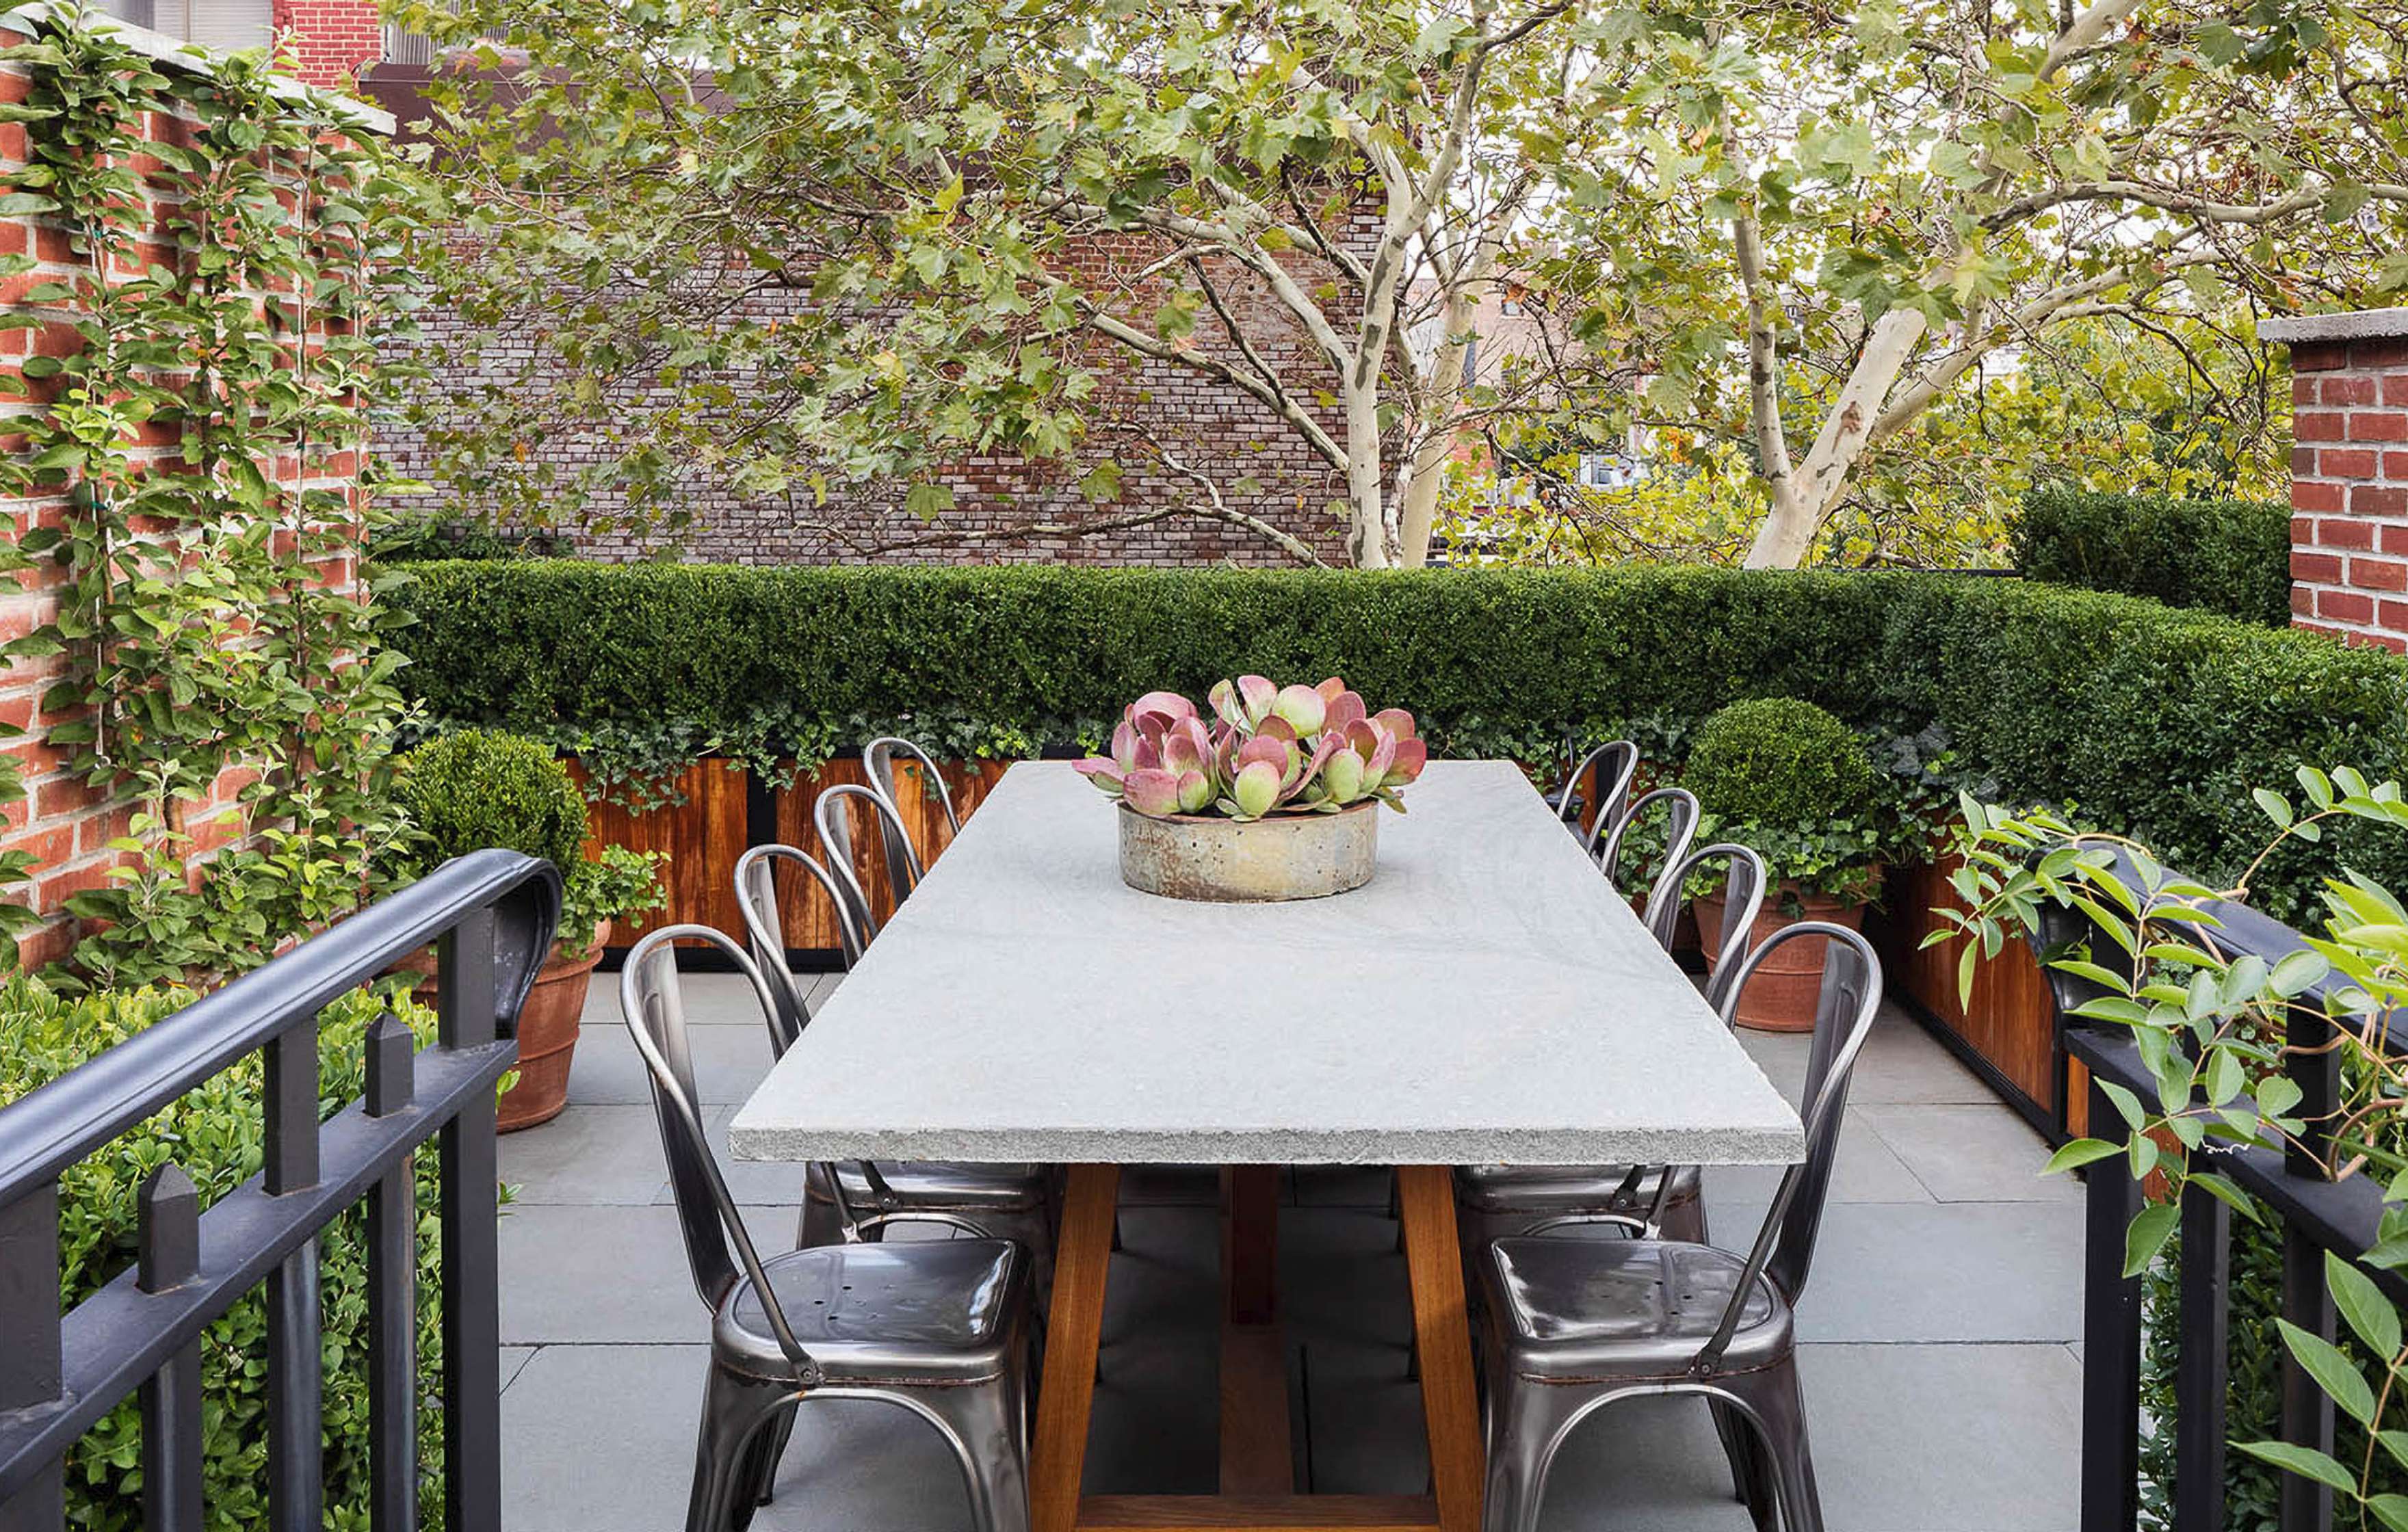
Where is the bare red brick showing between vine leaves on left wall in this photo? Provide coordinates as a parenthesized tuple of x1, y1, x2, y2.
(0, 18, 376, 966)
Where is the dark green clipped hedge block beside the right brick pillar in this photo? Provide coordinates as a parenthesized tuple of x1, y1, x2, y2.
(2013, 484, 2290, 629)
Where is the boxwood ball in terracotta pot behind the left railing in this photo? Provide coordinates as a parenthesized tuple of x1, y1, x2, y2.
(395, 730, 662, 1132)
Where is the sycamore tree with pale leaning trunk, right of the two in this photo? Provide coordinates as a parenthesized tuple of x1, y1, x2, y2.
(1539, 0, 2408, 566)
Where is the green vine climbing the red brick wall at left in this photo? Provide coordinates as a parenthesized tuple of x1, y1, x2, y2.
(0, 12, 412, 983)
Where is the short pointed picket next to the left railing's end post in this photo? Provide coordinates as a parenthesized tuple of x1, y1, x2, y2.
(364, 1012, 419, 1532)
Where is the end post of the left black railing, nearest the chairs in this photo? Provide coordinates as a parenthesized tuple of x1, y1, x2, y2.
(436, 910, 501, 1532)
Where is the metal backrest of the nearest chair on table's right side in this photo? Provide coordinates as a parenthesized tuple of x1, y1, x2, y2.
(1698, 920, 1881, 1366)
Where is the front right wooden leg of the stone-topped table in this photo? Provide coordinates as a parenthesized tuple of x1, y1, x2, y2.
(1397, 1166, 1488, 1532)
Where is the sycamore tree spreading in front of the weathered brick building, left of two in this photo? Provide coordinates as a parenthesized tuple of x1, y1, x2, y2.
(404, 0, 1633, 568)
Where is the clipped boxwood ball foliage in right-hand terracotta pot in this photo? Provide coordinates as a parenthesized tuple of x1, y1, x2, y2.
(1681, 696, 1881, 824)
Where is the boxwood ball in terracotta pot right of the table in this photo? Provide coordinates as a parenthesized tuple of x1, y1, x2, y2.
(1681, 696, 1888, 1031)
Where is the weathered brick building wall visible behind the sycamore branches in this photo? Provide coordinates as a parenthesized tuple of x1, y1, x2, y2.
(380, 212, 1377, 566)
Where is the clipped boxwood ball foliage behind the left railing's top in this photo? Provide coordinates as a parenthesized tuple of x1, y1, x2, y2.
(397, 730, 585, 872)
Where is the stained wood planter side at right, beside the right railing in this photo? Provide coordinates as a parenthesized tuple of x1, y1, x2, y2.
(1876, 862, 2059, 1113)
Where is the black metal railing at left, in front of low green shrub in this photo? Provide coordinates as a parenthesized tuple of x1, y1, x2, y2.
(0, 850, 561, 1532)
